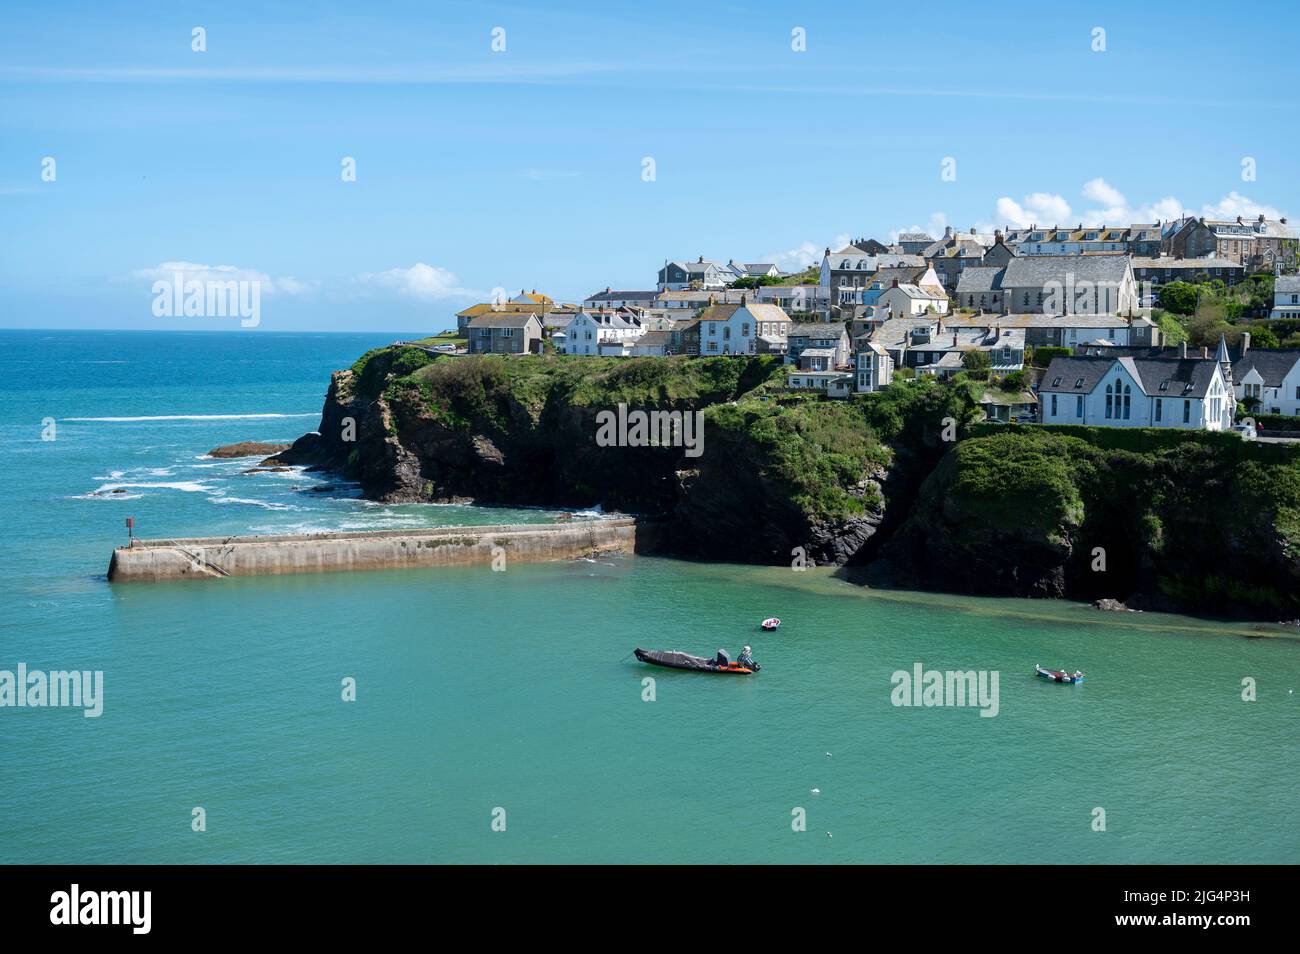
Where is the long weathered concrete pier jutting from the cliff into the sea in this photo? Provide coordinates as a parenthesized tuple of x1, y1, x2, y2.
(108, 517, 646, 582)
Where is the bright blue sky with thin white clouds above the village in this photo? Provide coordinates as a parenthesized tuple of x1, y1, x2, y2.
(0, 0, 1300, 331)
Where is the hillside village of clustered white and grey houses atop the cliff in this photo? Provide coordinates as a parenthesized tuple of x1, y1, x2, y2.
(456, 211, 1300, 429)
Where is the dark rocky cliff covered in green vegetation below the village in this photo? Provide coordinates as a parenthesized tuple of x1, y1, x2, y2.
(272, 347, 1300, 619)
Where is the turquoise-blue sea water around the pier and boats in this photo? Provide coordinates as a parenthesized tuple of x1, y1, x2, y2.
(0, 331, 1300, 863)
